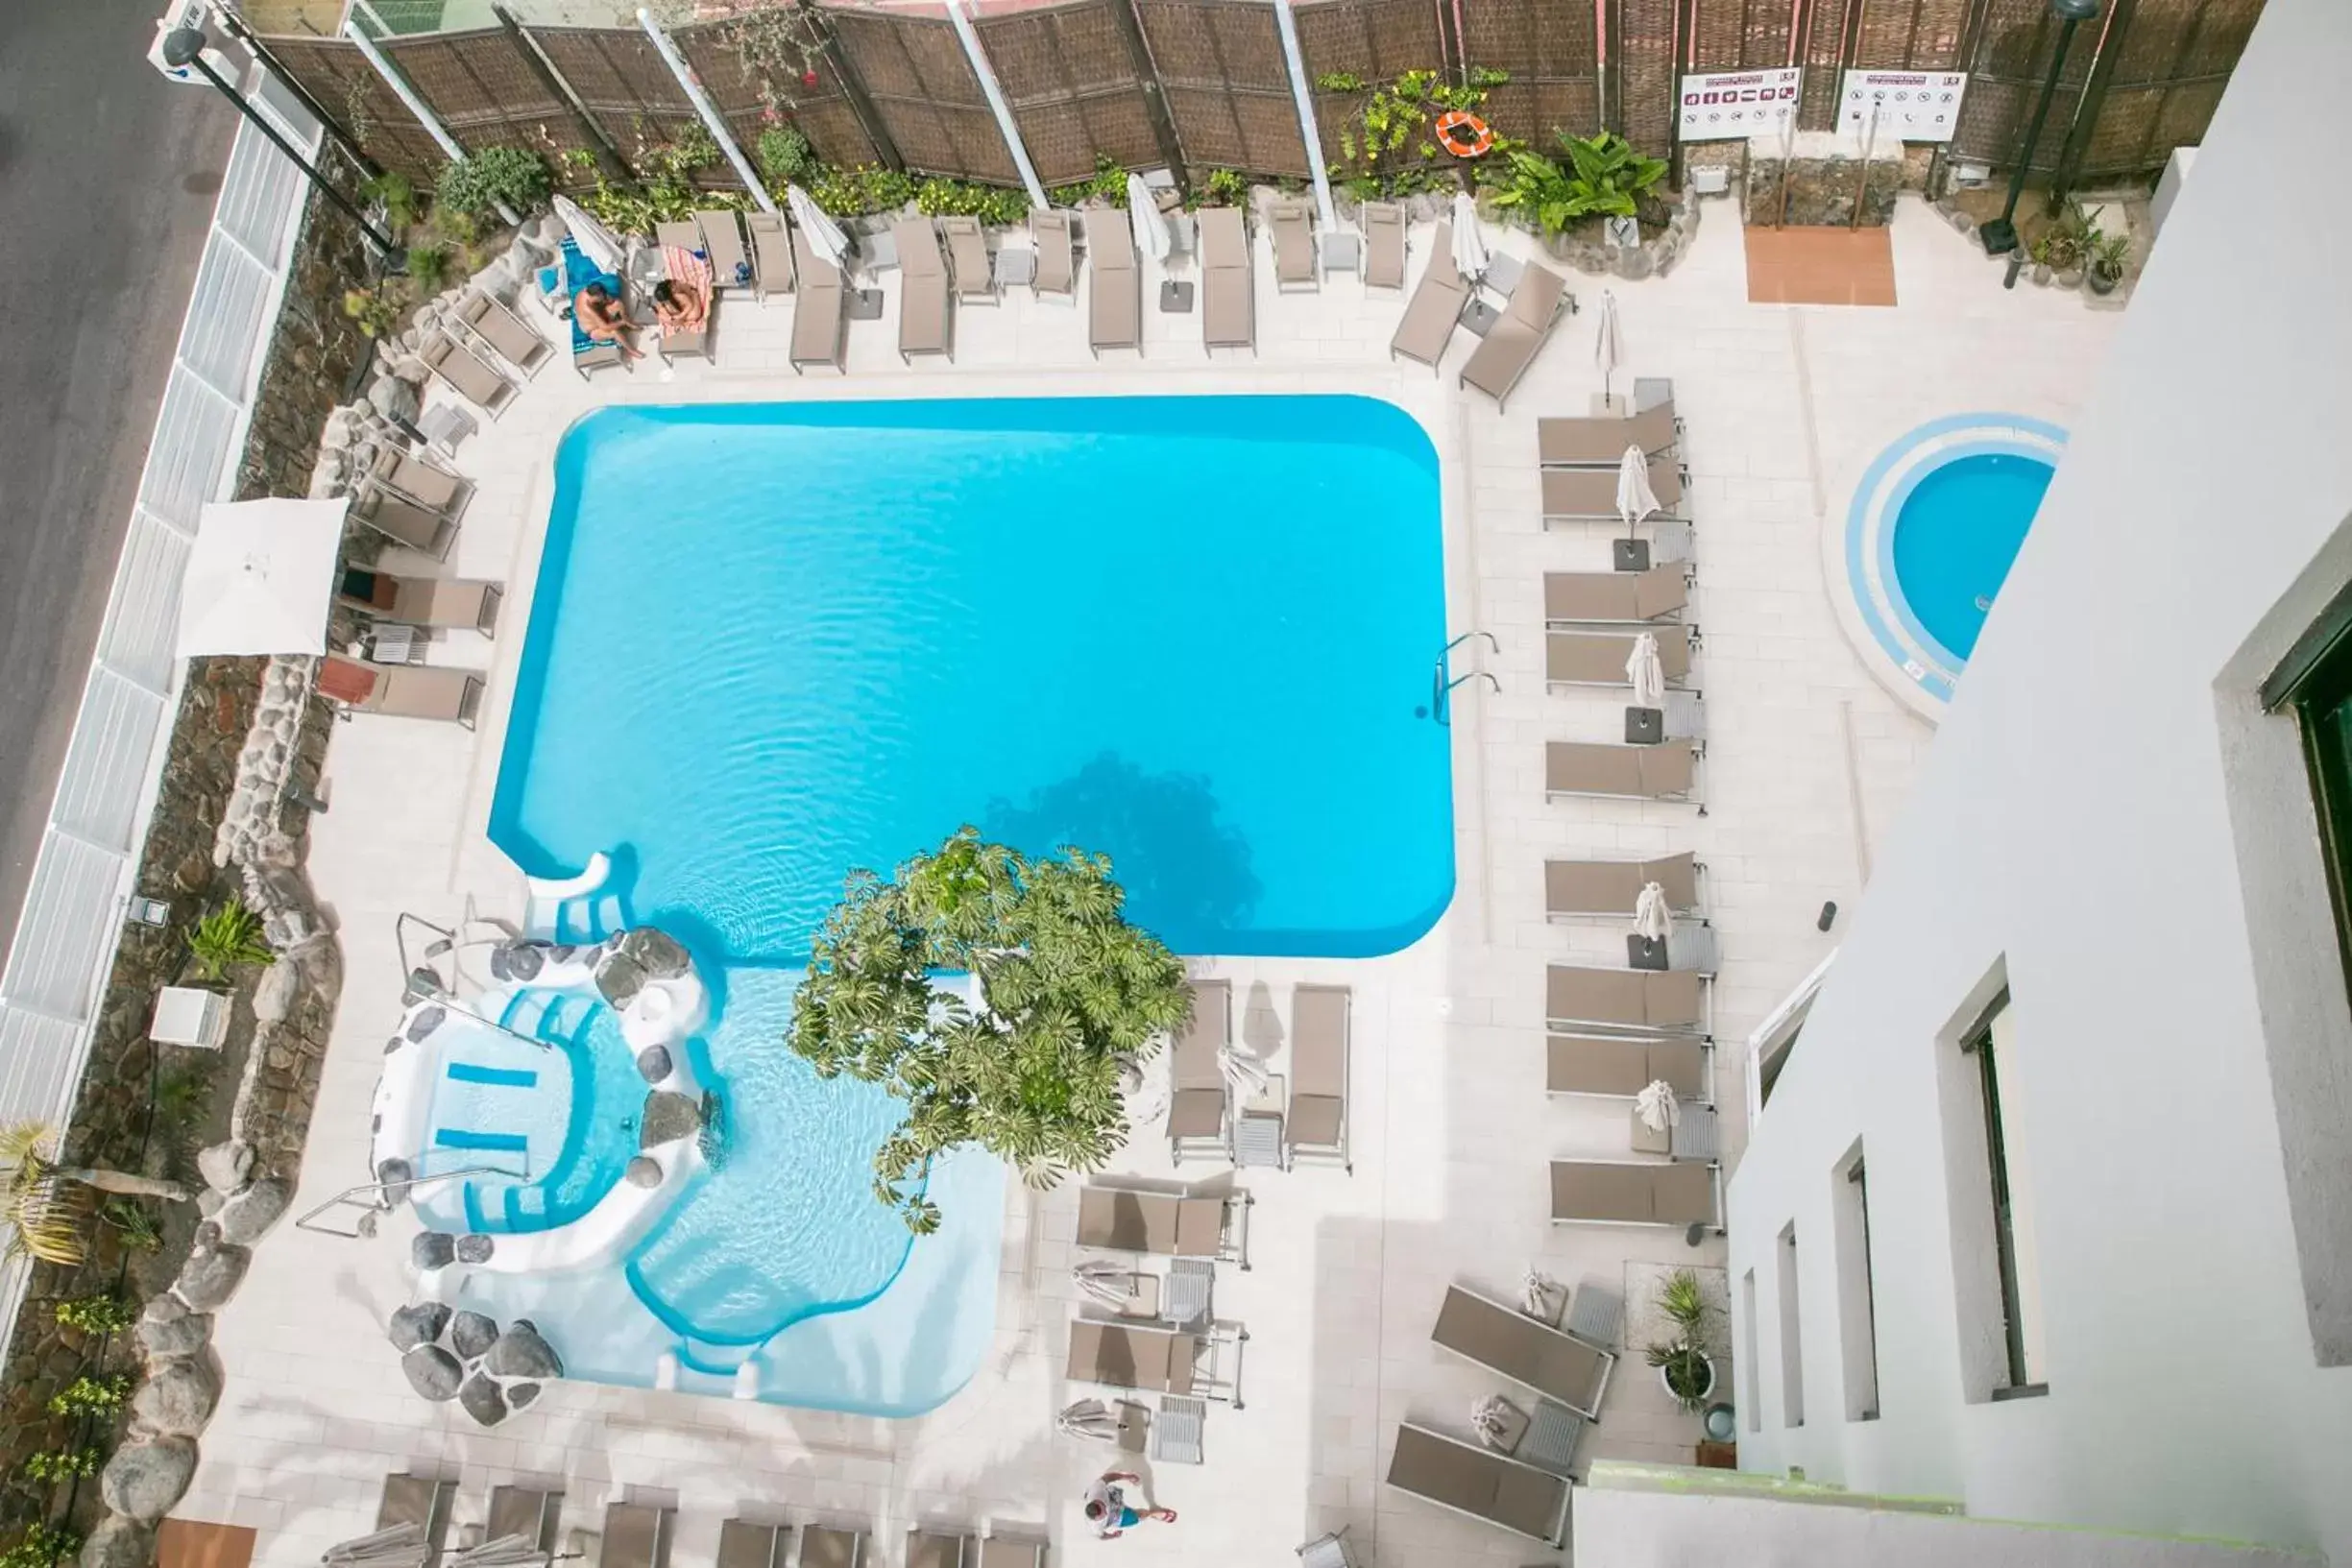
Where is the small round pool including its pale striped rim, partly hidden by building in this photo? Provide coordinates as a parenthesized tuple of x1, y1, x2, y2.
(1832, 414, 2065, 719)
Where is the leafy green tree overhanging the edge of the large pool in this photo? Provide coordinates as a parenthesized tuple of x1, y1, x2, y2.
(788, 828, 1193, 1234)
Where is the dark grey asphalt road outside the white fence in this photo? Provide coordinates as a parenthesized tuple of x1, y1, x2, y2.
(0, 0, 237, 968)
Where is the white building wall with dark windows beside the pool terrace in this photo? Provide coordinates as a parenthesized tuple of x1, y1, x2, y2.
(1729, 0, 2352, 1563)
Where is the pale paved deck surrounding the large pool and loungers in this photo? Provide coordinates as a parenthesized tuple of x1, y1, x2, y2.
(177, 200, 2117, 1568)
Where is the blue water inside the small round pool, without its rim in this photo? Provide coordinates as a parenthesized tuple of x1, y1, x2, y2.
(1893, 451, 2055, 661)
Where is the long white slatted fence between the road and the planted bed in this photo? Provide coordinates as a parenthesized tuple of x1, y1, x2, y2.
(0, 104, 318, 1354)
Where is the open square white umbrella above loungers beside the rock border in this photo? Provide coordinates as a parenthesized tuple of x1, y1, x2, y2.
(179, 500, 348, 659)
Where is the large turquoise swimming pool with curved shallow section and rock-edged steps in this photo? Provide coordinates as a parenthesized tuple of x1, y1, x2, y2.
(421, 398, 1453, 1415)
